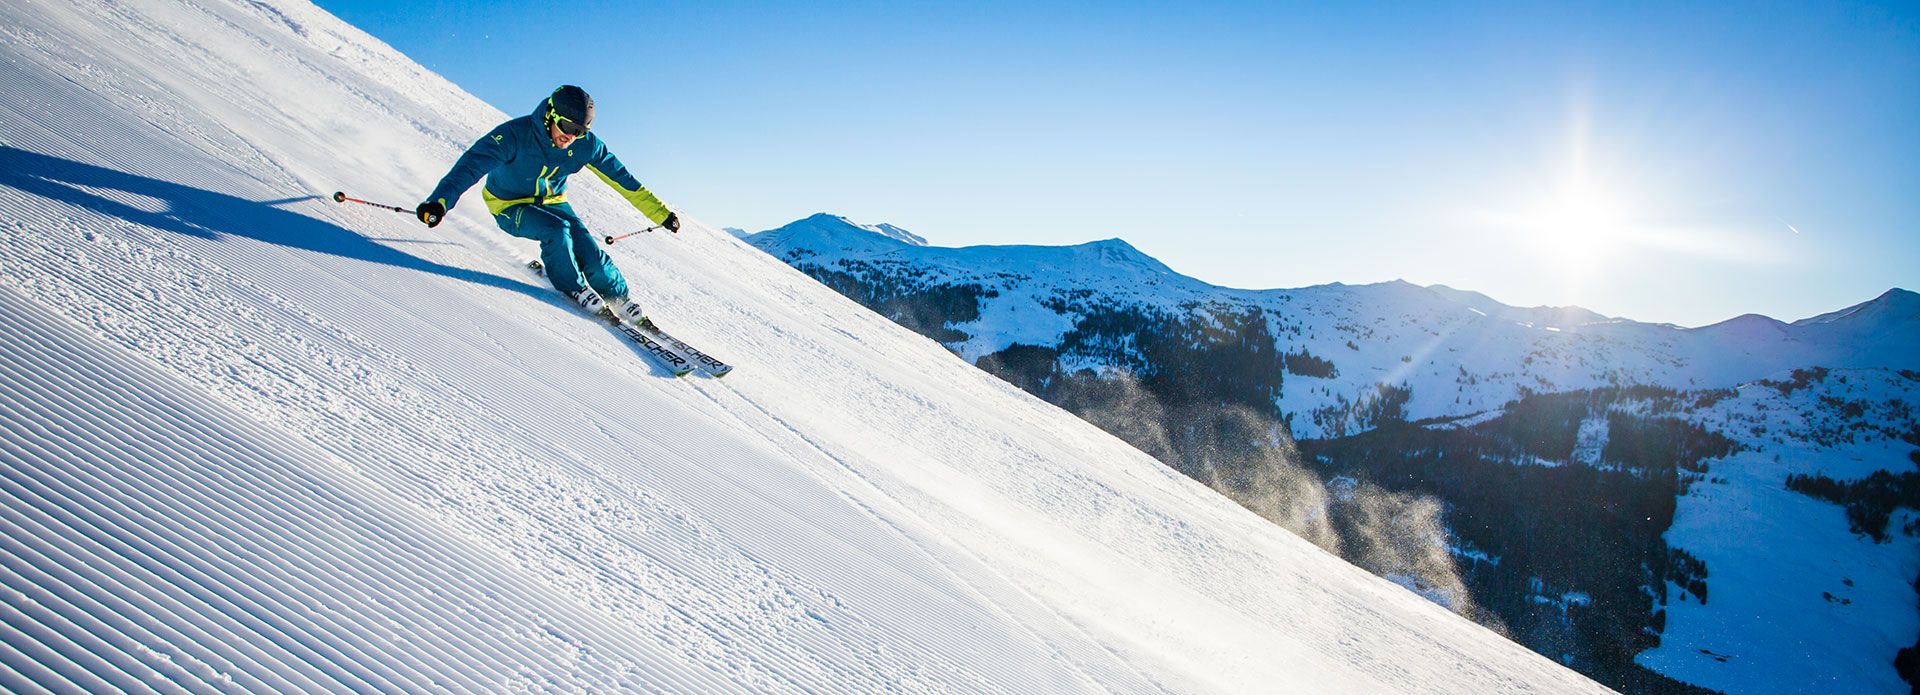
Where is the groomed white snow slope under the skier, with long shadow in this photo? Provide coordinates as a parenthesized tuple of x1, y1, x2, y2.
(0, 0, 1601, 693)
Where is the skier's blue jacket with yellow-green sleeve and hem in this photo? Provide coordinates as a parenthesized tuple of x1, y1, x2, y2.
(426, 98, 668, 225)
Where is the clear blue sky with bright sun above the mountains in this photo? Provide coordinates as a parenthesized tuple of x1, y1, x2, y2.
(319, 0, 1920, 326)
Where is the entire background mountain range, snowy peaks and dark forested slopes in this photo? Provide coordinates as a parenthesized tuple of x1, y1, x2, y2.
(749, 215, 1920, 693)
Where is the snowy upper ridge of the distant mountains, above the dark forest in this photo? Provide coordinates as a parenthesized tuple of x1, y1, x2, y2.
(749, 215, 1920, 438)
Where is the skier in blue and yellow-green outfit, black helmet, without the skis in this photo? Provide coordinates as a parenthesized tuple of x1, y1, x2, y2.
(413, 84, 680, 324)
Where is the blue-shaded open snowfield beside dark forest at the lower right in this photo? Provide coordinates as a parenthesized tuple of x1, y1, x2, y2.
(1636, 369, 1920, 693)
